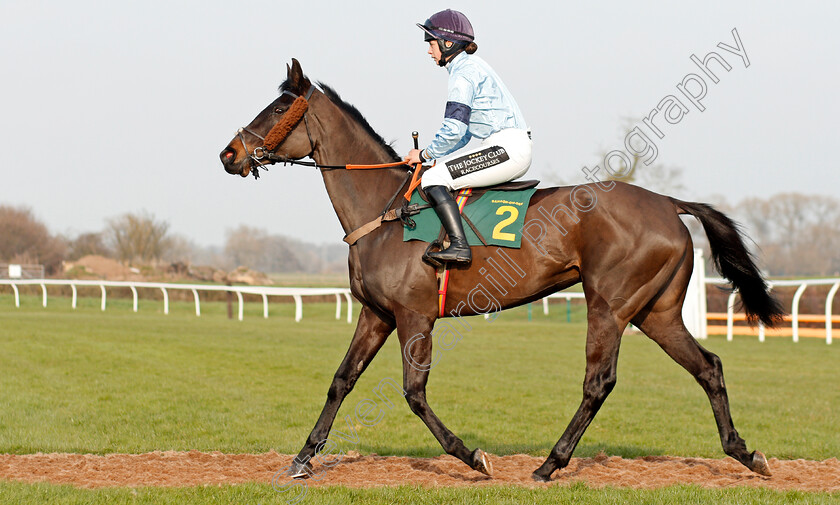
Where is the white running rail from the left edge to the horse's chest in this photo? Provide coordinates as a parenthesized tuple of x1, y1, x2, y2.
(0, 279, 353, 323)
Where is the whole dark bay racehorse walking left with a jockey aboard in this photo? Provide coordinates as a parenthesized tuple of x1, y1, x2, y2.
(220, 60, 783, 481)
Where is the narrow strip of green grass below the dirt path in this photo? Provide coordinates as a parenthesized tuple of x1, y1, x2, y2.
(0, 483, 840, 505)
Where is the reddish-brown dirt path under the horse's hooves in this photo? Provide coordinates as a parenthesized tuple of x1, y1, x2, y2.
(0, 451, 840, 491)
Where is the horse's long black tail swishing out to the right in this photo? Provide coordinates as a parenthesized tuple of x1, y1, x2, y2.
(671, 198, 785, 327)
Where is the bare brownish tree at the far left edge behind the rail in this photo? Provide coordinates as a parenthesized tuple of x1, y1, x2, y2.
(0, 205, 66, 274)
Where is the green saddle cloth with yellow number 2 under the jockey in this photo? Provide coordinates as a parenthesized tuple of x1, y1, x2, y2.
(403, 188, 537, 249)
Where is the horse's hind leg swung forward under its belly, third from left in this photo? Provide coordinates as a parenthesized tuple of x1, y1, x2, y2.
(531, 297, 621, 482)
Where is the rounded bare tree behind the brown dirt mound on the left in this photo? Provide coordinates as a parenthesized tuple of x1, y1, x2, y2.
(105, 211, 170, 264)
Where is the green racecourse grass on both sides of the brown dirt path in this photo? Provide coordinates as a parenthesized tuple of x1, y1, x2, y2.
(0, 291, 840, 503)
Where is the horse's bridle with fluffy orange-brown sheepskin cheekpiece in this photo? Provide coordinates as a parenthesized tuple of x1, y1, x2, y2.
(237, 86, 315, 179)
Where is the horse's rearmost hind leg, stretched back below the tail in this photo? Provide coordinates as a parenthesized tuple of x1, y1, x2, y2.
(633, 306, 770, 475)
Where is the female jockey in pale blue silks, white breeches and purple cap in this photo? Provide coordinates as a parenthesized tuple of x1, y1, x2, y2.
(405, 9, 531, 264)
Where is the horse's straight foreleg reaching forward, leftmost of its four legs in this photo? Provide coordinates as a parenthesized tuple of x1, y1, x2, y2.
(288, 307, 394, 478)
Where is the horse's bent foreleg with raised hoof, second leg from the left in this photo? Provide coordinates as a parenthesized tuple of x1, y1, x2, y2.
(397, 311, 493, 475)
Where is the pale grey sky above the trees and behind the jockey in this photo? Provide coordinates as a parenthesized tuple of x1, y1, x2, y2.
(0, 0, 840, 244)
